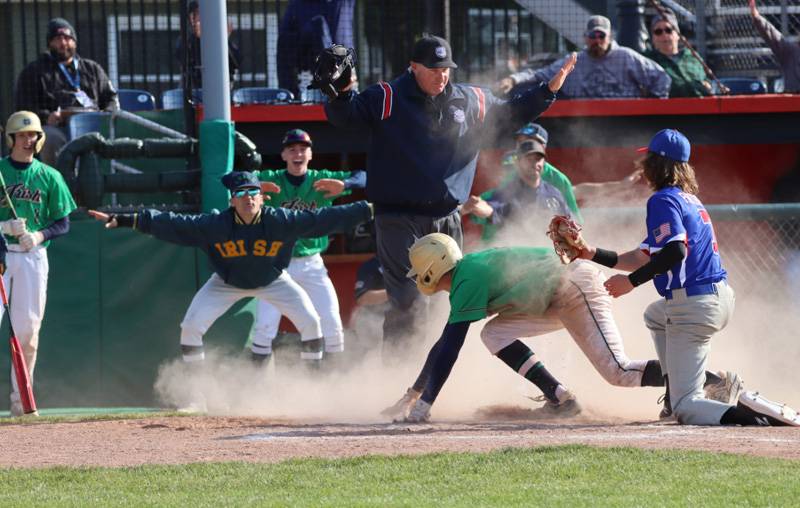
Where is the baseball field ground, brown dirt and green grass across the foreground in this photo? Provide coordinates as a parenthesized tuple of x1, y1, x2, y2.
(0, 407, 800, 506)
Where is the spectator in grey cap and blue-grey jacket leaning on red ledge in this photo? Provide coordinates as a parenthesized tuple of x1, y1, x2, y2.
(497, 16, 670, 99)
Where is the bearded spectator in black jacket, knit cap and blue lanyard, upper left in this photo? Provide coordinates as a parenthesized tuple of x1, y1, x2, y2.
(14, 18, 119, 166)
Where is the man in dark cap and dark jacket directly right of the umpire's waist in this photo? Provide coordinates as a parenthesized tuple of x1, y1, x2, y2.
(461, 132, 571, 240)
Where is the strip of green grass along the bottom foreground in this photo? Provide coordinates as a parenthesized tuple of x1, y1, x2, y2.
(0, 445, 800, 508)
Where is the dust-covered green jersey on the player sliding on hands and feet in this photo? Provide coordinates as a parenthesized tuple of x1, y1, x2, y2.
(447, 247, 564, 323)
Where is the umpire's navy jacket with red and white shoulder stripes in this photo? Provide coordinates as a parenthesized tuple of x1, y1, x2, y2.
(325, 71, 555, 216)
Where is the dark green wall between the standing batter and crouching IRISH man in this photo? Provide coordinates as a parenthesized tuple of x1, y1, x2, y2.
(0, 213, 253, 410)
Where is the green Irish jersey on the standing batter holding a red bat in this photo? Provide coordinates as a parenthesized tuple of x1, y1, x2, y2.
(0, 157, 76, 247)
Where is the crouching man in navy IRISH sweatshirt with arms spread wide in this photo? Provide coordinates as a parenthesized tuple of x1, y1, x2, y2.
(89, 171, 372, 408)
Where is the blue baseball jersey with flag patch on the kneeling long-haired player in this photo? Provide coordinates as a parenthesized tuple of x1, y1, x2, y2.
(641, 187, 727, 296)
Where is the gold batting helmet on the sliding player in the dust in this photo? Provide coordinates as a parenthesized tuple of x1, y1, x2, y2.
(406, 233, 463, 295)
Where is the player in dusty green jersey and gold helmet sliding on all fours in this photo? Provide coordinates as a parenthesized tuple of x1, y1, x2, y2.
(384, 233, 740, 422)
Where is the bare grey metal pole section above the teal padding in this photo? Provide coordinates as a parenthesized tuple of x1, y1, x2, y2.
(200, 0, 231, 122)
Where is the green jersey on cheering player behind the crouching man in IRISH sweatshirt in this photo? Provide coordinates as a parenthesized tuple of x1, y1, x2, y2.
(258, 169, 352, 258)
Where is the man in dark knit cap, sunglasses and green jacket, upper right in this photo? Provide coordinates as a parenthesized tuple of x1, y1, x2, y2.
(644, 9, 711, 97)
